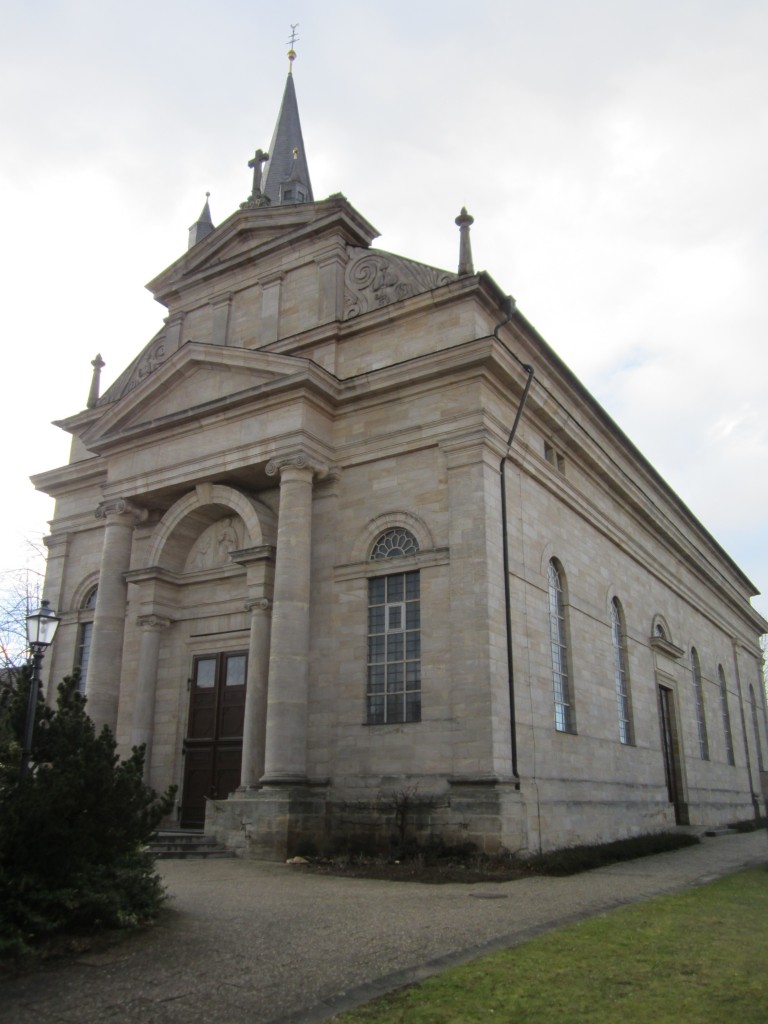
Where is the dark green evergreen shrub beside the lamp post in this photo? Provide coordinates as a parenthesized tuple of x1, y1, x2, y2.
(0, 668, 175, 955)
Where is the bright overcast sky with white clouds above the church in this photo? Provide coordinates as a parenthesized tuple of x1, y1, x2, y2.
(0, 0, 768, 614)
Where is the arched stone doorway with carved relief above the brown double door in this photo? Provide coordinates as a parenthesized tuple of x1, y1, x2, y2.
(136, 484, 276, 827)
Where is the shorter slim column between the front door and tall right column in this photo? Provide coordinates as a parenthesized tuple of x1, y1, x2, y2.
(240, 597, 272, 790)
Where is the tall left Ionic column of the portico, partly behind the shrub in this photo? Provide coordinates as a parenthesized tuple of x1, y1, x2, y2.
(85, 498, 146, 732)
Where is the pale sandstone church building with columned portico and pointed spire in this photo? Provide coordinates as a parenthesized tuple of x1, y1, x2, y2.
(34, 51, 768, 858)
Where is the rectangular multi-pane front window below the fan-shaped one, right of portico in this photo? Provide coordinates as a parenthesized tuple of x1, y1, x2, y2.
(366, 570, 421, 725)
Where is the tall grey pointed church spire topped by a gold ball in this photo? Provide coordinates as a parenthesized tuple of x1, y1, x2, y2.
(263, 33, 314, 206)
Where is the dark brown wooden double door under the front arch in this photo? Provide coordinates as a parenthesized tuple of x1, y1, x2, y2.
(180, 651, 248, 828)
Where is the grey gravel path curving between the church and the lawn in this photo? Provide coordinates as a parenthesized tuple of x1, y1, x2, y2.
(0, 831, 768, 1024)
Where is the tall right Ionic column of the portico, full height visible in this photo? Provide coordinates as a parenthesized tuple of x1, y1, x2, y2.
(261, 456, 325, 783)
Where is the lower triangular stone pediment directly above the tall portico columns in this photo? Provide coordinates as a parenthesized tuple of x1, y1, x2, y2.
(83, 342, 309, 452)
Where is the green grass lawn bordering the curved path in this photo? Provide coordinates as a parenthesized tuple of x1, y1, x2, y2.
(333, 865, 768, 1024)
